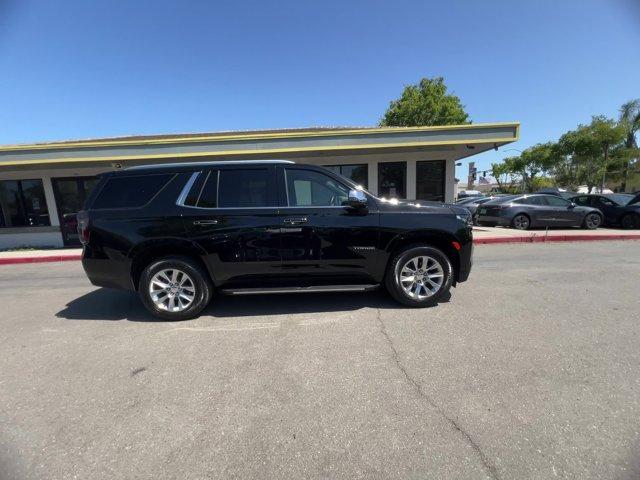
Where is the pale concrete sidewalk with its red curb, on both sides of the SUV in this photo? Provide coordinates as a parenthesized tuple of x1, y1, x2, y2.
(0, 227, 640, 265)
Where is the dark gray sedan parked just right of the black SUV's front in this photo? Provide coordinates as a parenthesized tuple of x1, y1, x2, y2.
(476, 194, 602, 230)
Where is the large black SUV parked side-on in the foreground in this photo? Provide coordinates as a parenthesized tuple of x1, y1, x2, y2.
(78, 161, 473, 320)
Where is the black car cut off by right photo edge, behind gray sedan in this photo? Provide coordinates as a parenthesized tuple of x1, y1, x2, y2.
(572, 193, 640, 228)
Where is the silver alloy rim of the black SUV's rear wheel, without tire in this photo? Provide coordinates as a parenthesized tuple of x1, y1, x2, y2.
(149, 268, 196, 312)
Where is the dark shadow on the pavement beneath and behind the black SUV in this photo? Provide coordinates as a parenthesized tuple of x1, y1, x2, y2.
(56, 288, 451, 322)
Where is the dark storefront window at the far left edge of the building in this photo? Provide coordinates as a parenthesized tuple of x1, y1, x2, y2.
(0, 179, 51, 228)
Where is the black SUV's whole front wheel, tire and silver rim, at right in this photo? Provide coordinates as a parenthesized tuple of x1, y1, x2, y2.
(385, 245, 453, 307)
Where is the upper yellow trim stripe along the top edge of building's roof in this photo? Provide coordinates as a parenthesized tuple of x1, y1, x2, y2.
(0, 122, 520, 151)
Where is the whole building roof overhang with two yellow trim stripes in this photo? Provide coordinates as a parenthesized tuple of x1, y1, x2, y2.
(0, 122, 520, 171)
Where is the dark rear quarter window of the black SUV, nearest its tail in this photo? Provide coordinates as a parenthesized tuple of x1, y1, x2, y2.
(92, 173, 174, 209)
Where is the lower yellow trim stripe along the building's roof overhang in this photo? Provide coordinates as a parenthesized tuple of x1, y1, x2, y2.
(0, 137, 515, 167)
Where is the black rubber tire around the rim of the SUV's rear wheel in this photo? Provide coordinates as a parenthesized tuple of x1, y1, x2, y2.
(138, 256, 213, 320)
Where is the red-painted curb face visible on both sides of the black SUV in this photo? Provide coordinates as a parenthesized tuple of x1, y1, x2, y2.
(0, 234, 640, 265)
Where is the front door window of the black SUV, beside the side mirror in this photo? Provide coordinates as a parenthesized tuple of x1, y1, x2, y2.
(286, 169, 349, 207)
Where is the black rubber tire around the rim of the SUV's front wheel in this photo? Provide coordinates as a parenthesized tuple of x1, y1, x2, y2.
(385, 245, 453, 308)
